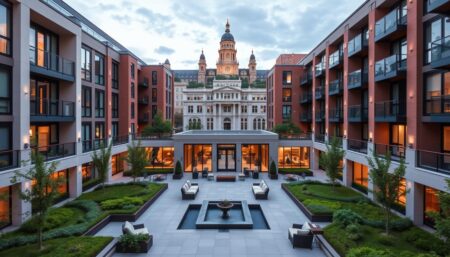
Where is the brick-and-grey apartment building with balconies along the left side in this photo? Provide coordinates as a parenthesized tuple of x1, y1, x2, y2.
(0, 0, 173, 227)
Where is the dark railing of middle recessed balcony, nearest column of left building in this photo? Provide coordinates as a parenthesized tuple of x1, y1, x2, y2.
(30, 98, 75, 117)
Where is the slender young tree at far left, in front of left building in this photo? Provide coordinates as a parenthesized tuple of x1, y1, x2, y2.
(11, 151, 64, 250)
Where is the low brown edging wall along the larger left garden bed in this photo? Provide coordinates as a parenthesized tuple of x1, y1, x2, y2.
(83, 184, 169, 236)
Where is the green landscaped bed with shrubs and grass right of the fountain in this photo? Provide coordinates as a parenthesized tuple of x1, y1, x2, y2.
(283, 181, 450, 257)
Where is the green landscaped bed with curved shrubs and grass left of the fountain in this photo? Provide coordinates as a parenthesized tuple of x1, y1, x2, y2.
(0, 183, 167, 249)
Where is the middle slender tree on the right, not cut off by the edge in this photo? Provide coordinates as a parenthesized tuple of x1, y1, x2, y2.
(367, 151, 407, 235)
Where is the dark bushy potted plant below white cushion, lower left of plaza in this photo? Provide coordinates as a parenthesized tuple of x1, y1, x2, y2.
(116, 234, 153, 253)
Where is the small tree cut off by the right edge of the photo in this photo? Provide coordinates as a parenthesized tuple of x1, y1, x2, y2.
(433, 179, 450, 242)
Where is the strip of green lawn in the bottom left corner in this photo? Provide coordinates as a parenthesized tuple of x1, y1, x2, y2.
(0, 237, 112, 257)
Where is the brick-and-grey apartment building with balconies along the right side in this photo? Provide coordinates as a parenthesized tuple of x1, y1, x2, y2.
(268, 0, 450, 225)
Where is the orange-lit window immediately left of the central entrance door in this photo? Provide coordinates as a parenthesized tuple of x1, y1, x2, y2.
(184, 145, 212, 172)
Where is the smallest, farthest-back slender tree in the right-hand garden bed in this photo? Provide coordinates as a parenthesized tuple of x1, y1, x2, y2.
(319, 137, 345, 190)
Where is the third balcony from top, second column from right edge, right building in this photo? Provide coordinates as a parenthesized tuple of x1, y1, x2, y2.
(375, 101, 406, 123)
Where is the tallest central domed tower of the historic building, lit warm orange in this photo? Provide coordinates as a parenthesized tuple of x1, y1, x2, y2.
(216, 19, 239, 75)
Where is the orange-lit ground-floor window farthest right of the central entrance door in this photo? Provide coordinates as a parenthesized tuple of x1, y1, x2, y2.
(278, 147, 309, 169)
